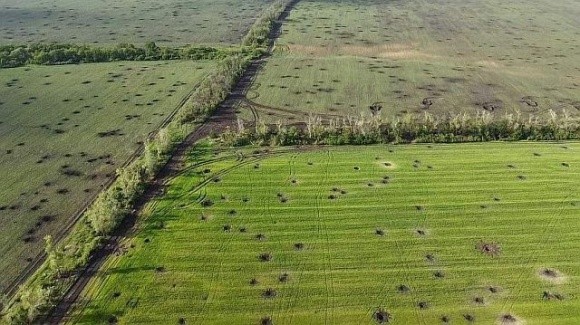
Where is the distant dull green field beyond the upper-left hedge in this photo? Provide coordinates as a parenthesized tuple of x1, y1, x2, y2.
(0, 0, 271, 45)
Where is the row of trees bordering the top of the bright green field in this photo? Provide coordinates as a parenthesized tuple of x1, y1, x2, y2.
(221, 112, 580, 146)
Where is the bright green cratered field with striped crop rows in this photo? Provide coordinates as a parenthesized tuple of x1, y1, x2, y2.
(70, 142, 580, 324)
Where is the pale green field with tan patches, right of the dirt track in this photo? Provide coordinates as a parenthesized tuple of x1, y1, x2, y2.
(241, 0, 580, 122)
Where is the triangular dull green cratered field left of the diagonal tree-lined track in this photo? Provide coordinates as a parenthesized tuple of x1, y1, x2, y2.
(0, 62, 213, 292)
